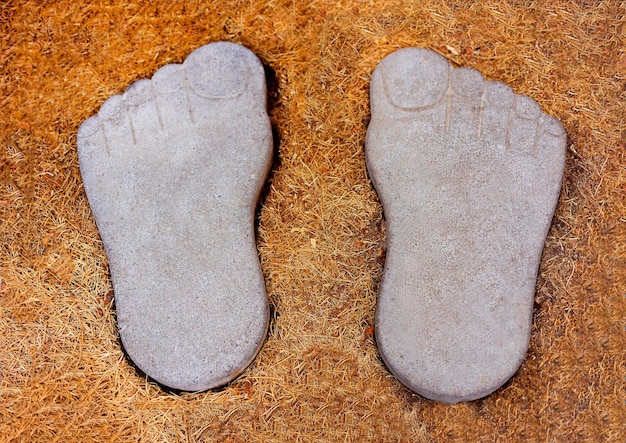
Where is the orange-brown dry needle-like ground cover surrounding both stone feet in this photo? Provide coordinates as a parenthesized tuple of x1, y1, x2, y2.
(0, 0, 626, 442)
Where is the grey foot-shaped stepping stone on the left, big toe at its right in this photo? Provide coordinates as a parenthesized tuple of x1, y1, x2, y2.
(78, 42, 272, 391)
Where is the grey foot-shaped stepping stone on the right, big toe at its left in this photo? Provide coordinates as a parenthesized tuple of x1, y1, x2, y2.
(366, 48, 566, 403)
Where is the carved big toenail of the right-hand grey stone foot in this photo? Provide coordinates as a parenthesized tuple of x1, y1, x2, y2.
(380, 48, 450, 109)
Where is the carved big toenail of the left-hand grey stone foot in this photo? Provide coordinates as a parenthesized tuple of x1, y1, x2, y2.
(184, 42, 250, 98)
